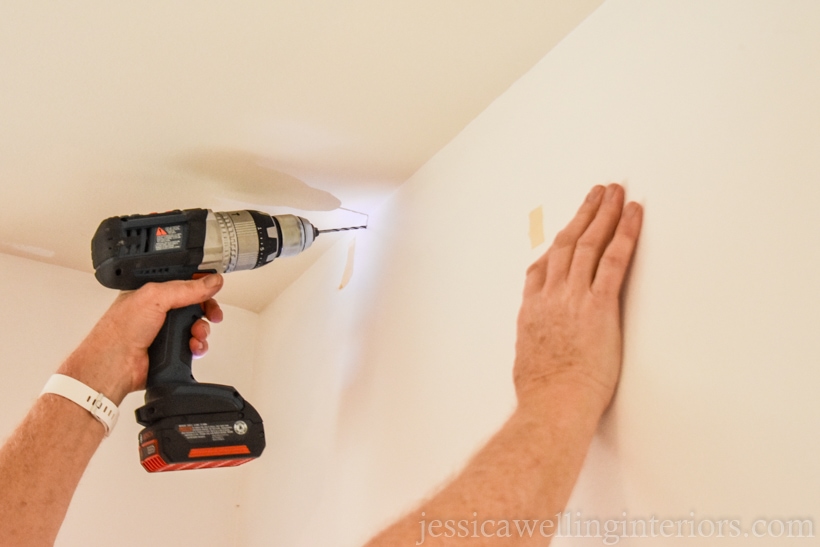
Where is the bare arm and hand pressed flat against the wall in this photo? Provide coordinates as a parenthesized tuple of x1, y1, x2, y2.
(369, 184, 643, 547)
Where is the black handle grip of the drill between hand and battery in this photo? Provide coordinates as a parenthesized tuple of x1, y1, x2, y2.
(145, 304, 204, 389)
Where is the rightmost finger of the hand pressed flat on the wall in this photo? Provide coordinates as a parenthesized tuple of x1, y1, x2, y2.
(592, 202, 643, 297)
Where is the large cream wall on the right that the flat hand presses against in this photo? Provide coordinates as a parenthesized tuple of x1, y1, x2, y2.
(243, 0, 820, 546)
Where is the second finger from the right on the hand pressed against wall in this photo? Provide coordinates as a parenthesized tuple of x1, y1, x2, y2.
(569, 184, 624, 289)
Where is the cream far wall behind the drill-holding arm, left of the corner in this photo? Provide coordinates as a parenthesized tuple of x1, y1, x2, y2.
(0, 254, 257, 547)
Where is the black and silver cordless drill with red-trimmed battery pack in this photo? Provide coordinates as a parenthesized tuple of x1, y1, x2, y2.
(91, 209, 320, 472)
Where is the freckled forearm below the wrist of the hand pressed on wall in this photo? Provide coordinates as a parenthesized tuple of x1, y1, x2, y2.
(368, 383, 602, 547)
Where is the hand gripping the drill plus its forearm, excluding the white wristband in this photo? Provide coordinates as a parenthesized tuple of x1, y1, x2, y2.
(0, 275, 222, 546)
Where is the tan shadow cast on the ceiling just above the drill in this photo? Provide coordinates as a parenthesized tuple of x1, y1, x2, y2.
(173, 149, 342, 211)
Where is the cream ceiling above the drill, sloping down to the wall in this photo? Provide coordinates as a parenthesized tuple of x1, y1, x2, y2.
(0, 0, 603, 311)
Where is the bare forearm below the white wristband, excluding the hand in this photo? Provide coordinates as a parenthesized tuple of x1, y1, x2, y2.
(0, 394, 104, 546)
